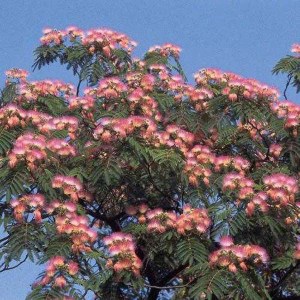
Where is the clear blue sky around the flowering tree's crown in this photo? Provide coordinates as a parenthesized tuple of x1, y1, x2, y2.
(0, 0, 300, 300)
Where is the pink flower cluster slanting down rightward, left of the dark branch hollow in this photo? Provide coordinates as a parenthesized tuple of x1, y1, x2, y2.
(52, 175, 92, 201)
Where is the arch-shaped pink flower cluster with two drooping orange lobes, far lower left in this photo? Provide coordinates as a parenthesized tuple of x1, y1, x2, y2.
(10, 194, 45, 223)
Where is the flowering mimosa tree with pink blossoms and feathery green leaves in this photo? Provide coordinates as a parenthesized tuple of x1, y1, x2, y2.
(0, 27, 300, 300)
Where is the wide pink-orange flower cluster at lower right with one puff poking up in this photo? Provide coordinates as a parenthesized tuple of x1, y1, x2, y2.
(209, 236, 269, 273)
